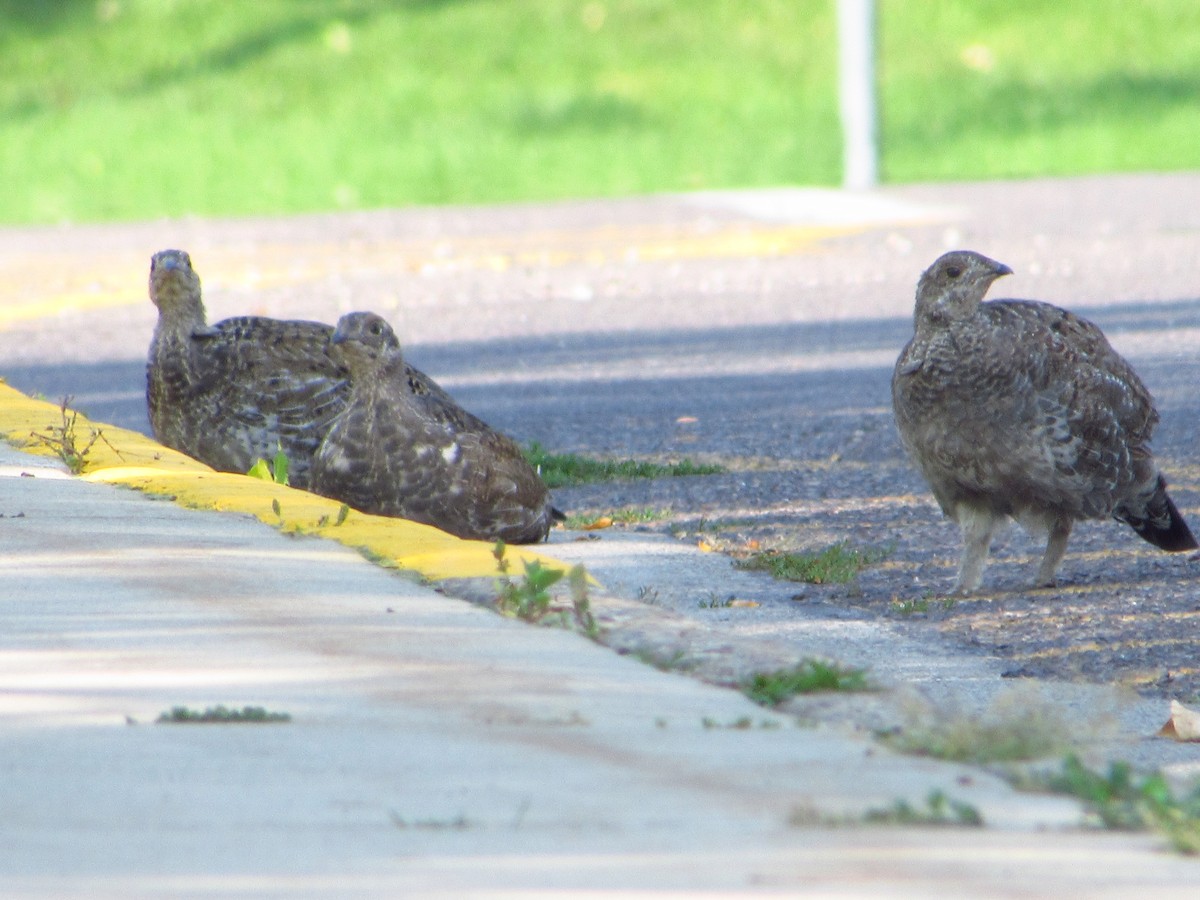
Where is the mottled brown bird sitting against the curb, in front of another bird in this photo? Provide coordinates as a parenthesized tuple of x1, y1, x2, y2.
(312, 312, 560, 544)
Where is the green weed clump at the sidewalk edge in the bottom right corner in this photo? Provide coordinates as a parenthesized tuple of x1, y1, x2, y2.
(1036, 755, 1200, 856)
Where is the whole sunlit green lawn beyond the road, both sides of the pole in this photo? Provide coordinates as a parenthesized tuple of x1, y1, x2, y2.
(0, 0, 1200, 223)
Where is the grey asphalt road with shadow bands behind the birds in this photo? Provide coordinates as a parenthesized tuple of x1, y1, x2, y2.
(7, 174, 1200, 700)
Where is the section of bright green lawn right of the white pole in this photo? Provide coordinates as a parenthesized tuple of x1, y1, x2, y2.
(880, 0, 1200, 181)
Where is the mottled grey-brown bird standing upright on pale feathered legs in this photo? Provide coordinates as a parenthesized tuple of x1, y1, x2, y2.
(892, 251, 1196, 593)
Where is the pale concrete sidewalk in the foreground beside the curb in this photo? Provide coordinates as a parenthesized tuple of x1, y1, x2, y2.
(0, 420, 1200, 898)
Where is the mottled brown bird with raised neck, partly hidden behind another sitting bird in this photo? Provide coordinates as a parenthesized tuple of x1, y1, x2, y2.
(146, 250, 452, 488)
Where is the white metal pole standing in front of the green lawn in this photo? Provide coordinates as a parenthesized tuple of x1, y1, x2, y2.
(838, 0, 878, 190)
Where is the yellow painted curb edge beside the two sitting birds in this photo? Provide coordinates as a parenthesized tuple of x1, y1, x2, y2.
(0, 383, 570, 580)
